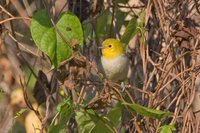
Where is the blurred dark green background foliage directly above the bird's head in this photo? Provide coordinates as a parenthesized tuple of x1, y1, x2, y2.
(83, 8, 128, 40)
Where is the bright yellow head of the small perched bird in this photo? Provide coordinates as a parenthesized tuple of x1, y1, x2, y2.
(102, 38, 125, 59)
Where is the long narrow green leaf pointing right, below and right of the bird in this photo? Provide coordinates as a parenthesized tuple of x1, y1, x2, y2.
(122, 103, 172, 119)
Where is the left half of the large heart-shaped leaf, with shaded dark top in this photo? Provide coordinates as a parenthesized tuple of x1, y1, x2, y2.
(31, 10, 56, 59)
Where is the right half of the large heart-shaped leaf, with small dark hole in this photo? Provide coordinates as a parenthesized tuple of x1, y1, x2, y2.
(56, 12, 83, 63)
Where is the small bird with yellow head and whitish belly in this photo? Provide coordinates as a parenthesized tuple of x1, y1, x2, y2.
(99, 38, 129, 82)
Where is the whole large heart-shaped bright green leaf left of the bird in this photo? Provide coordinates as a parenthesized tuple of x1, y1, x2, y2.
(31, 10, 83, 67)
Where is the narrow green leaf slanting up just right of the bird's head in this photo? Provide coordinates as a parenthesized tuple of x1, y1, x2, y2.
(121, 18, 138, 45)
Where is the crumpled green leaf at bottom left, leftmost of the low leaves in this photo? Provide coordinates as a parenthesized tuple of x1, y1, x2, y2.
(48, 99, 74, 133)
